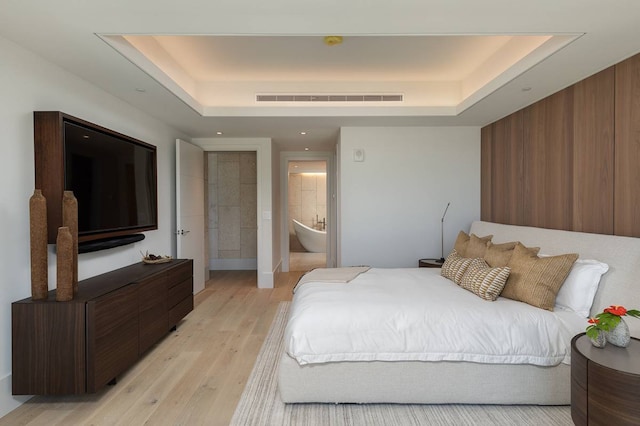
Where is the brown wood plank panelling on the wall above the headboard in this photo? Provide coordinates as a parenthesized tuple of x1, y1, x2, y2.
(481, 51, 640, 237)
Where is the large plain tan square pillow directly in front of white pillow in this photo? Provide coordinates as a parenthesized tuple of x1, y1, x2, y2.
(501, 243, 578, 311)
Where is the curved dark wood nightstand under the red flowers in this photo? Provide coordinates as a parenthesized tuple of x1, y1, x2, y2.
(571, 333, 640, 426)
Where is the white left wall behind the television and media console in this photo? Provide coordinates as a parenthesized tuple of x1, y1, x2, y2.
(0, 38, 183, 416)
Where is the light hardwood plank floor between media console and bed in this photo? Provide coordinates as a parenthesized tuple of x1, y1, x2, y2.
(0, 271, 302, 426)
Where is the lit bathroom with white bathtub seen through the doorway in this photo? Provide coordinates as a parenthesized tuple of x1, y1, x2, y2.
(288, 161, 327, 271)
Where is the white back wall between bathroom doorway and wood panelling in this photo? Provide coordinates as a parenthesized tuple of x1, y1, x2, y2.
(338, 127, 480, 267)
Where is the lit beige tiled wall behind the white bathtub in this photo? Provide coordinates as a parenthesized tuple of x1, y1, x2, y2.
(288, 173, 327, 251)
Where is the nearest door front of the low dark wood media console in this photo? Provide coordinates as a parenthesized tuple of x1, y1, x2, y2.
(87, 284, 139, 392)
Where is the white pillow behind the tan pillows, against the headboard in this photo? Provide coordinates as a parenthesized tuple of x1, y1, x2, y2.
(555, 259, 609, 318)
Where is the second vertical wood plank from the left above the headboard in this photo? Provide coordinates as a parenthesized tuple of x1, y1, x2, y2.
(491, 111, 524, 225)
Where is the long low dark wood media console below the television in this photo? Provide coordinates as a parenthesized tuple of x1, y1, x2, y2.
(11, 259, 193, 395)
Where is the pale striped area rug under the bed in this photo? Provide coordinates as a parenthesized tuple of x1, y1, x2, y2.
(231, 302, 573, 426)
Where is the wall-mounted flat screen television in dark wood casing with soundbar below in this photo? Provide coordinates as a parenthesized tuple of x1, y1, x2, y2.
(34, 112, 158, 253)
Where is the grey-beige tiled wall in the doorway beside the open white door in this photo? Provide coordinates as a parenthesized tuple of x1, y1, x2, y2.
(208, 152, 258, 270)
